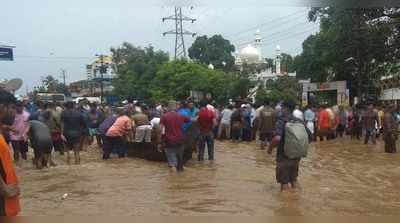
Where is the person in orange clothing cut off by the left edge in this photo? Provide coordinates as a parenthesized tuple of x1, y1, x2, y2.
(0, 89, 21, 217)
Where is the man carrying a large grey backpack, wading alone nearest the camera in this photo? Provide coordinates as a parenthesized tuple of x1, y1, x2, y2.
(268, 103, 311, 191)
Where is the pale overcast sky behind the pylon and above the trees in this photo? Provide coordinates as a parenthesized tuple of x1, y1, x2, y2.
(0, 0, 318, 92)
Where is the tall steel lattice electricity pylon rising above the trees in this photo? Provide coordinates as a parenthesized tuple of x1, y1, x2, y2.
(162, 7, 196, 59)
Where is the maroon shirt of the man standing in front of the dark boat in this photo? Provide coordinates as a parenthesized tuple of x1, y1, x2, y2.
(160, 111, 190, 145)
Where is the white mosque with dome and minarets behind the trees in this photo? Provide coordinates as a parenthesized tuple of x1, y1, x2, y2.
(235, 30, 296, 100)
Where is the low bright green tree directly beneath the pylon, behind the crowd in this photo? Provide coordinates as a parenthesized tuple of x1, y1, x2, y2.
(150, 60, 248, 103)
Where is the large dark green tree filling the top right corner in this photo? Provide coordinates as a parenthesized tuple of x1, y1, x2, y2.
(294, 7, 399, 99)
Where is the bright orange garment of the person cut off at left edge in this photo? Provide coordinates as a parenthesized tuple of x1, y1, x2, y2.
(0, 134, 21, 216)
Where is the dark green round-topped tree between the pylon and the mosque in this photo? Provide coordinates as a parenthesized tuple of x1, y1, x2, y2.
(189, 35, 235, 70)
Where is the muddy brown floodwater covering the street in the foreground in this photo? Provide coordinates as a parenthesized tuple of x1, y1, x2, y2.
(18, 139, 400, 216)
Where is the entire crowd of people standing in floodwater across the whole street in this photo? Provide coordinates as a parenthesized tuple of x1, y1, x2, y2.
(0, 86, 400, 215)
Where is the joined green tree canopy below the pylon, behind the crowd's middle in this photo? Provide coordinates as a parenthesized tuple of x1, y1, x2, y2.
(111, 43, 250, 103)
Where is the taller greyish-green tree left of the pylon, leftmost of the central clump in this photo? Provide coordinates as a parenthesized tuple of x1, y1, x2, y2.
(111, 43, 169, 99)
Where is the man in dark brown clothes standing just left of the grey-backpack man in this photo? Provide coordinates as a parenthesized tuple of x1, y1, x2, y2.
(259, 101, 276, 149)
